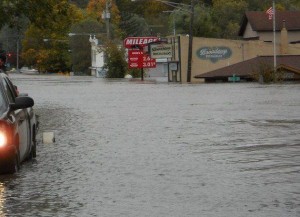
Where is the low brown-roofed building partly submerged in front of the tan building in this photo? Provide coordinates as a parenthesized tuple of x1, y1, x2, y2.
(195, 55, 300, 82)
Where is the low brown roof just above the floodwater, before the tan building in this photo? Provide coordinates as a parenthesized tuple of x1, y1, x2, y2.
(195, 55, 300, 78)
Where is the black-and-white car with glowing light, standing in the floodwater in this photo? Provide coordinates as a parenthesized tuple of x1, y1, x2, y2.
(0, 72, 38, 174)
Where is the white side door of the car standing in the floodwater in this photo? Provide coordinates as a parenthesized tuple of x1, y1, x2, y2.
(3, 79, 30, 161)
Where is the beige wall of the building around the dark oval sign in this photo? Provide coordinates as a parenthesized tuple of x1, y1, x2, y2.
(175, 36, 300, 83)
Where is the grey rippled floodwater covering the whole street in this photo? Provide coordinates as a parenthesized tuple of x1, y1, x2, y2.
(0, 75, 300, 217)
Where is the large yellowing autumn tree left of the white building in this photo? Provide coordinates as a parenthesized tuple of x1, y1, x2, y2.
(21, 0, 83, 72)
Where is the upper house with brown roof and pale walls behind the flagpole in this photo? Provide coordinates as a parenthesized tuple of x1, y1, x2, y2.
(239, 11, 300, 44)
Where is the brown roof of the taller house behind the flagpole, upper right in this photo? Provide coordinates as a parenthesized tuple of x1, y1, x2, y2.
(239, 11, 300, 36)
